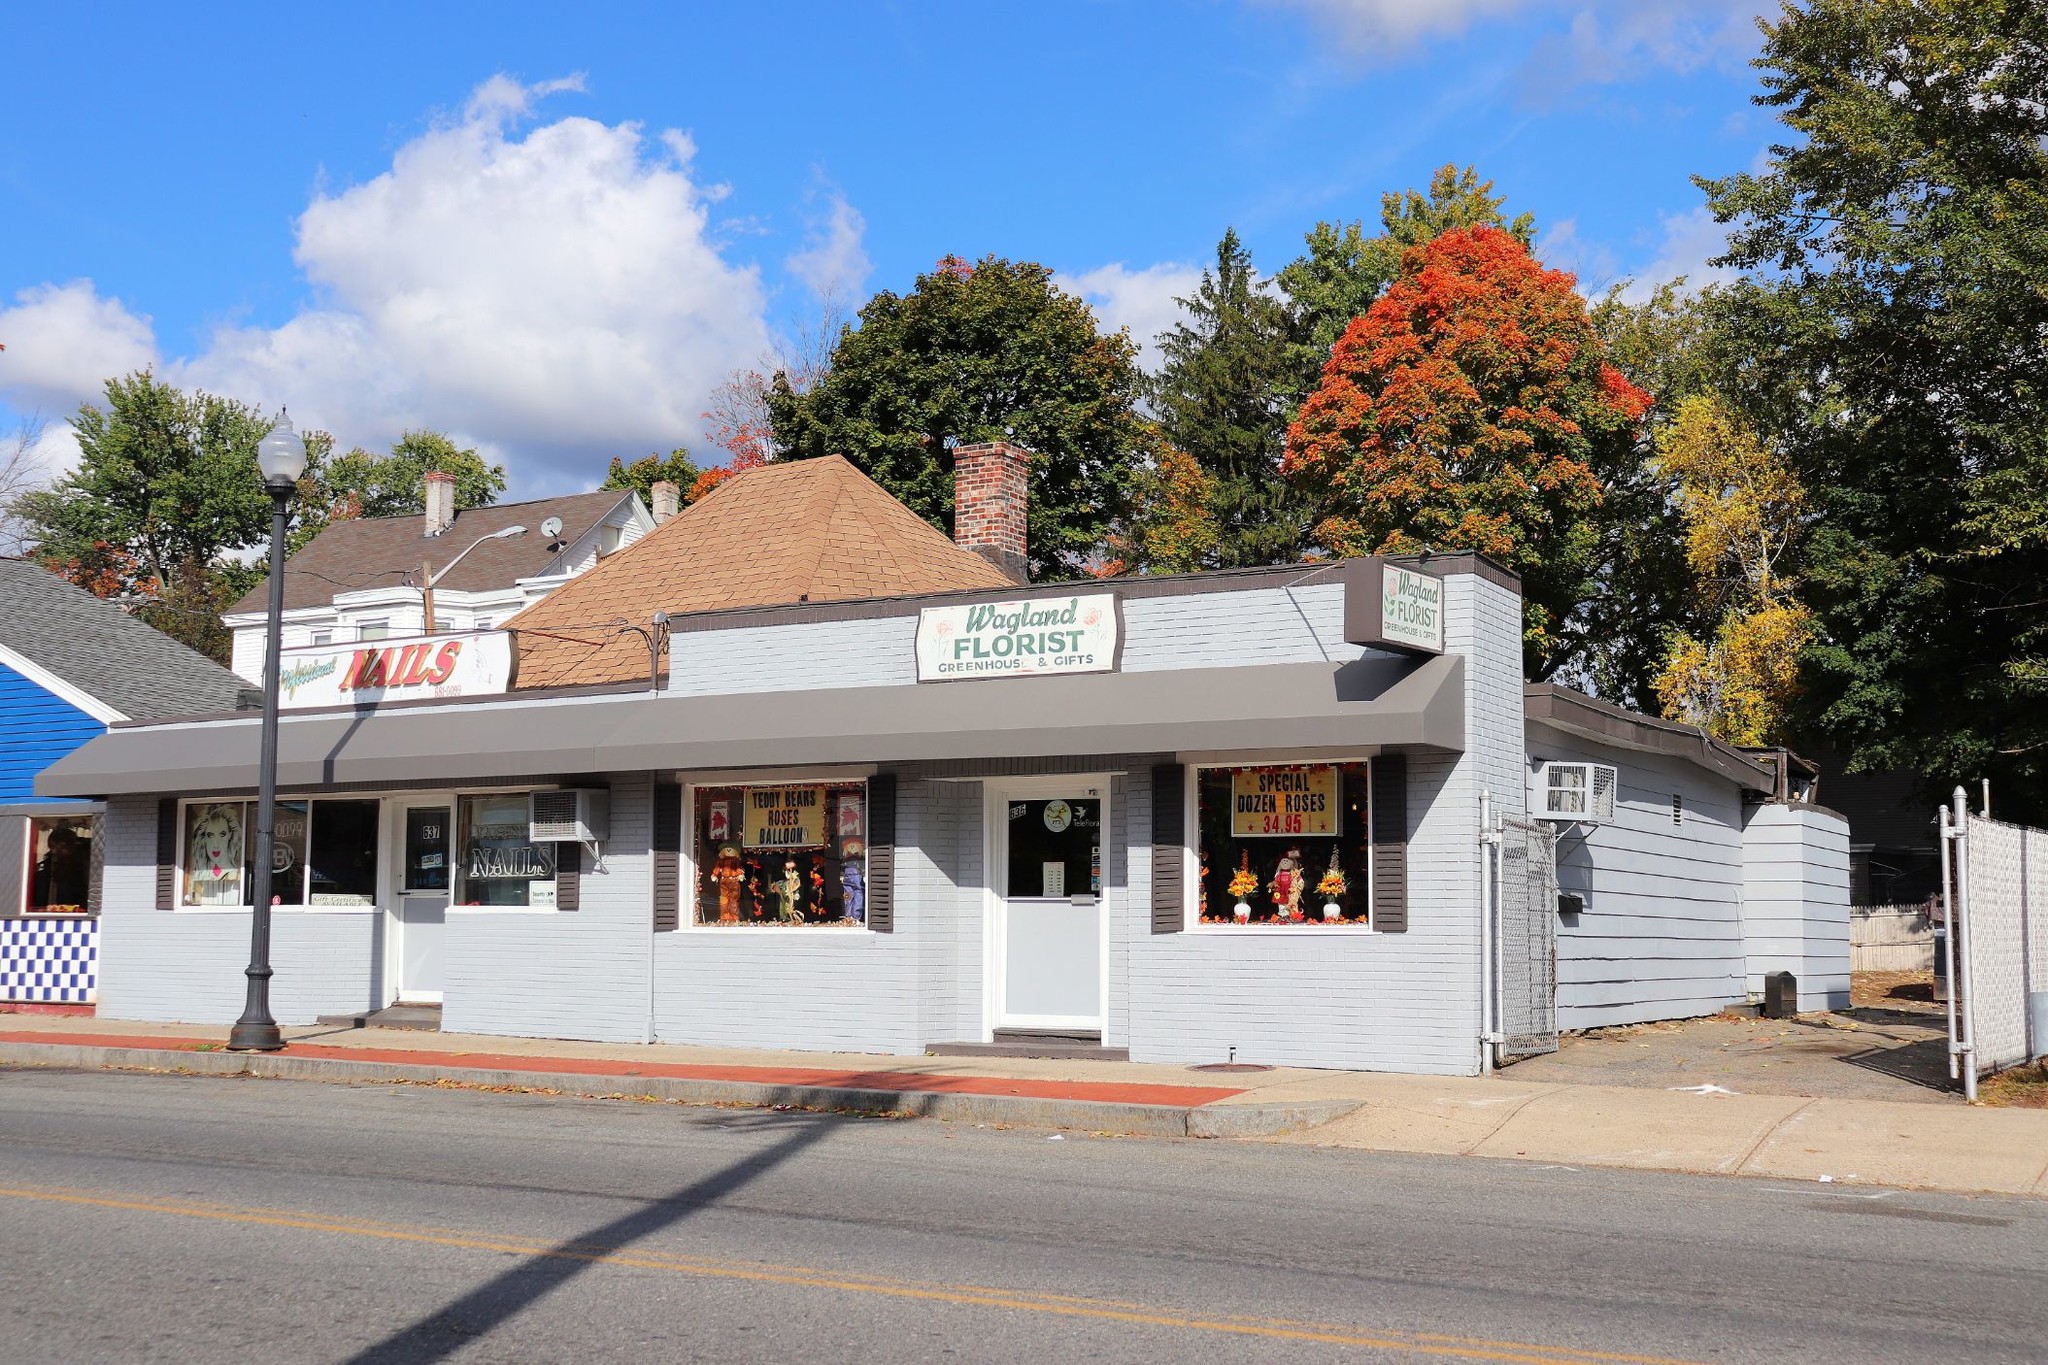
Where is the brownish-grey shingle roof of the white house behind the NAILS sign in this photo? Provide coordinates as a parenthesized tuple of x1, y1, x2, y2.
(227, 489, 635, 614)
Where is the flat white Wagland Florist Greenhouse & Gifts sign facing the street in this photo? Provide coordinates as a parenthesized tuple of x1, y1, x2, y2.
(918, 593, 1116, 681)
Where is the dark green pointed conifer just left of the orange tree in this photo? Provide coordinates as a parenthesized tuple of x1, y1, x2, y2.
(1137, 229, 1309, 569)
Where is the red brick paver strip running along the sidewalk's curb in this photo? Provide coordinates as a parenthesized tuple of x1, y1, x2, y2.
(0, 1029, 1243, 1109)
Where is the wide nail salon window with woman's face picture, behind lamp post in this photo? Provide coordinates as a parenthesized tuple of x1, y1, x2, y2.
(180, 800, 381, 909)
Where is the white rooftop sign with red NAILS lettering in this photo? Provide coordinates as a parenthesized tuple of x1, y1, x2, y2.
(276, 630, 512, 710)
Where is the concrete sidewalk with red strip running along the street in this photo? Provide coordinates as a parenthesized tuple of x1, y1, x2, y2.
(0, 1015, 2048, 1197)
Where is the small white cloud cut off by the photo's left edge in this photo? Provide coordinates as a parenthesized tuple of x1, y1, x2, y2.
(0, 280, 156, 426)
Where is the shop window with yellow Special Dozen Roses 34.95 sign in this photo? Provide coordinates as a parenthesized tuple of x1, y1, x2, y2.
(1196, 763, 1372, 927)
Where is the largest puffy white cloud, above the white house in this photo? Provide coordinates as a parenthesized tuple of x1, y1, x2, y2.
(172, 76, 768, 491)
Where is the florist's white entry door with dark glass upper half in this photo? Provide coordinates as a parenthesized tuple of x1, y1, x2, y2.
(993, 784, 1108, 1036)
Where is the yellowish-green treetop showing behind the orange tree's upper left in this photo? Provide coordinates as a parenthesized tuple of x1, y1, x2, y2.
(1274, 166, 1536, 405)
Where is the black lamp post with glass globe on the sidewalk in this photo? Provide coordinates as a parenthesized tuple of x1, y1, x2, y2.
(227, 411, 305, 1052)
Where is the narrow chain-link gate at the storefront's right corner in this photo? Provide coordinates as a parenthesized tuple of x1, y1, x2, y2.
(1493, 819, 1556, 1062)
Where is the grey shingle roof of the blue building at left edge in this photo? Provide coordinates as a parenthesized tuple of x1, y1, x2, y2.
(0, 559, 248, 720)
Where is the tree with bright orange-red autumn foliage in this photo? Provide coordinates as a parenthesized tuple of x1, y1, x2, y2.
(1282, 225, 1651, 677)
